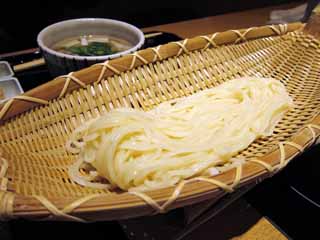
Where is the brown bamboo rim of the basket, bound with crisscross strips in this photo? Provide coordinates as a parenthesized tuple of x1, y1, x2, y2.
(0, 19, 320, 221)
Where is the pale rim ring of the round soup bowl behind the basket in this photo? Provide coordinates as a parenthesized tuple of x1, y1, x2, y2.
(37, 18, 145, 61)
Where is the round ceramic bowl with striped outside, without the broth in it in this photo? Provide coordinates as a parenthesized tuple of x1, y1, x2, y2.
(37, 18, 145, 76)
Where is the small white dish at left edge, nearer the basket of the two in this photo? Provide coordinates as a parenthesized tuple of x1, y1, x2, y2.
(0, 77, 24, 103)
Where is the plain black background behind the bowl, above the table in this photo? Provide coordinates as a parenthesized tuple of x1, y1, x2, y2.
(0, 0, 301, 53)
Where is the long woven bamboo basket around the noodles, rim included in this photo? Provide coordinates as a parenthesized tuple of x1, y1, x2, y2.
(0, 13, 320, 221)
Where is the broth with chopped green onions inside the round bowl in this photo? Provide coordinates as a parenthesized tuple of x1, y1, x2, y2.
(52, 35, 133, 56)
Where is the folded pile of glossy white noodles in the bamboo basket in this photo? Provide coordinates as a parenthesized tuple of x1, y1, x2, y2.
(67, 77, 293, 191)
